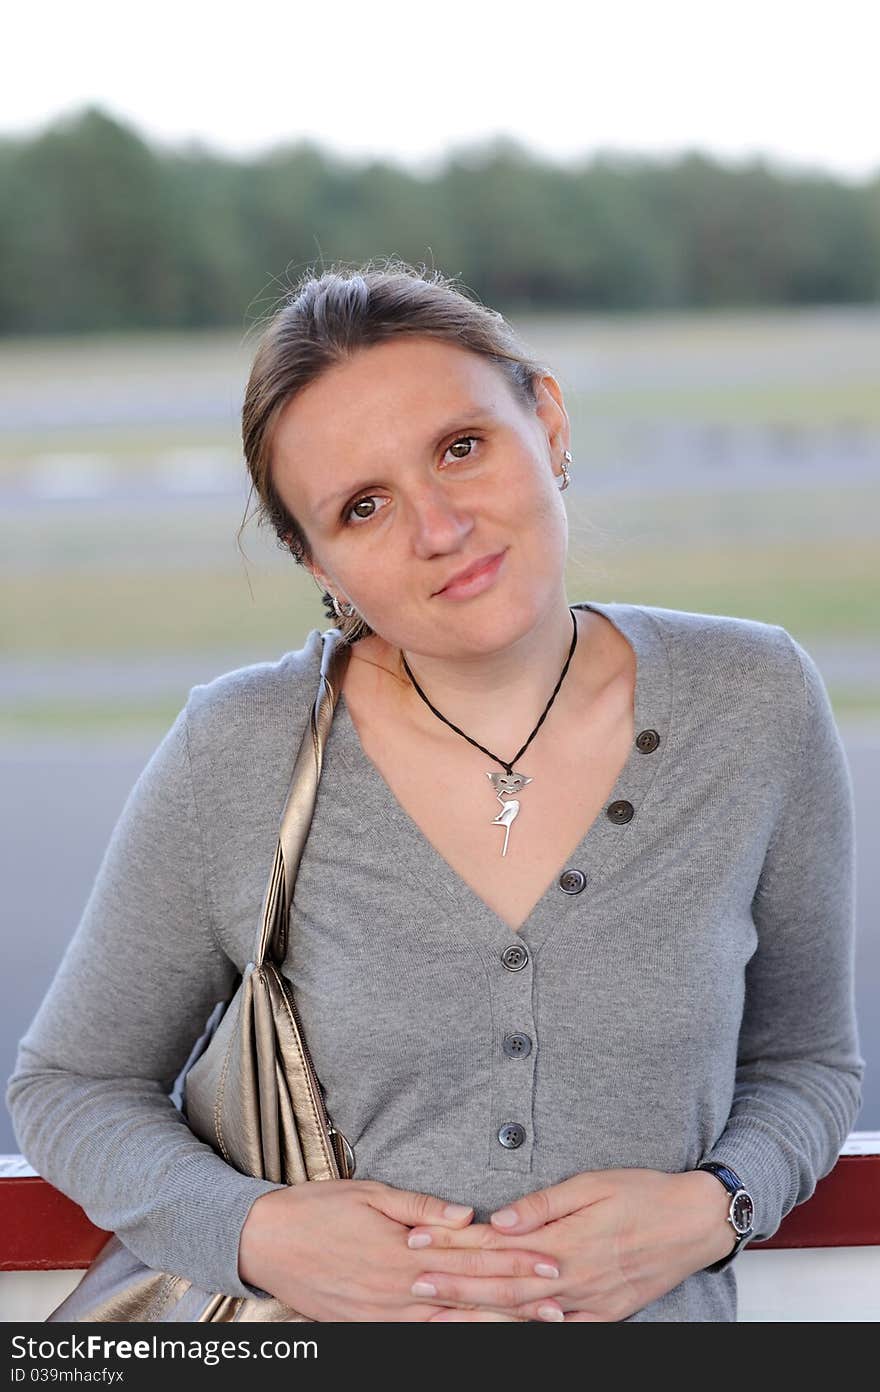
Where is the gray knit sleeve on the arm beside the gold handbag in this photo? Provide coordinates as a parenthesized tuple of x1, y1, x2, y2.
(7, 710, 283, 1295)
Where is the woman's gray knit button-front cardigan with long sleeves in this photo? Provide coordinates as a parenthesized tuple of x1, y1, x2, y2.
(7, 601, 865, 1321)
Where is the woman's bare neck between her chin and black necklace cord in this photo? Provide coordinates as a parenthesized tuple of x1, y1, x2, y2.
(402, 596, 576, 759)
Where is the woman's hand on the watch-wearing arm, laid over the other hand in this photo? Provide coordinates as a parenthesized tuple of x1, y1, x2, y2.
(407, 1169, 735, 1322)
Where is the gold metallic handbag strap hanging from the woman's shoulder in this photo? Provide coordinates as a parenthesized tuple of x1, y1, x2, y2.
(253, 628, 351, 966)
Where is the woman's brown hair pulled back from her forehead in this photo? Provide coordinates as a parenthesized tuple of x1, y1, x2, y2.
(241, 259, 546, 642)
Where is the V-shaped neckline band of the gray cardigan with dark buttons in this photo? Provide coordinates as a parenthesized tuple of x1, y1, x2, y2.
(331, 600, 673, 951)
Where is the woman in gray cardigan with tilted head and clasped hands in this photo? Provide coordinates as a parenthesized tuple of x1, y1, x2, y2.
(8, 264, 863, 1322)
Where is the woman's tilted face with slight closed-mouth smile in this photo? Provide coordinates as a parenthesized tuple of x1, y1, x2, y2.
(272, 337, 569, 657)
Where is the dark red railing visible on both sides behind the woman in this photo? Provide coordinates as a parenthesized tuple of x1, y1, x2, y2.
(0, 1153, 880, 1271)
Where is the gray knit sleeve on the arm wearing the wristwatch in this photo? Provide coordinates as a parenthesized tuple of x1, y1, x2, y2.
(702, 635, 865, 1239)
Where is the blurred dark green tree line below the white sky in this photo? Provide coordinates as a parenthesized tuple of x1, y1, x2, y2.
(0, 107, 880, 334)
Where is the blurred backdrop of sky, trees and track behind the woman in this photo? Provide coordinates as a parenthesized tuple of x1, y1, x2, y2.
(0, 0, 880, 1151)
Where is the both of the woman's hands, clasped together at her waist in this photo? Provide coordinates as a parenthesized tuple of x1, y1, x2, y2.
(239, 1169, 734, 1322)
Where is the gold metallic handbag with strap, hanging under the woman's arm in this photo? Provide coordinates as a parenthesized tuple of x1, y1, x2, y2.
(46, 628, 354, 1324)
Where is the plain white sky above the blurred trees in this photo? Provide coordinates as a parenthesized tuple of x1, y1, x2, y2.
(6, 0, 880, 178)
